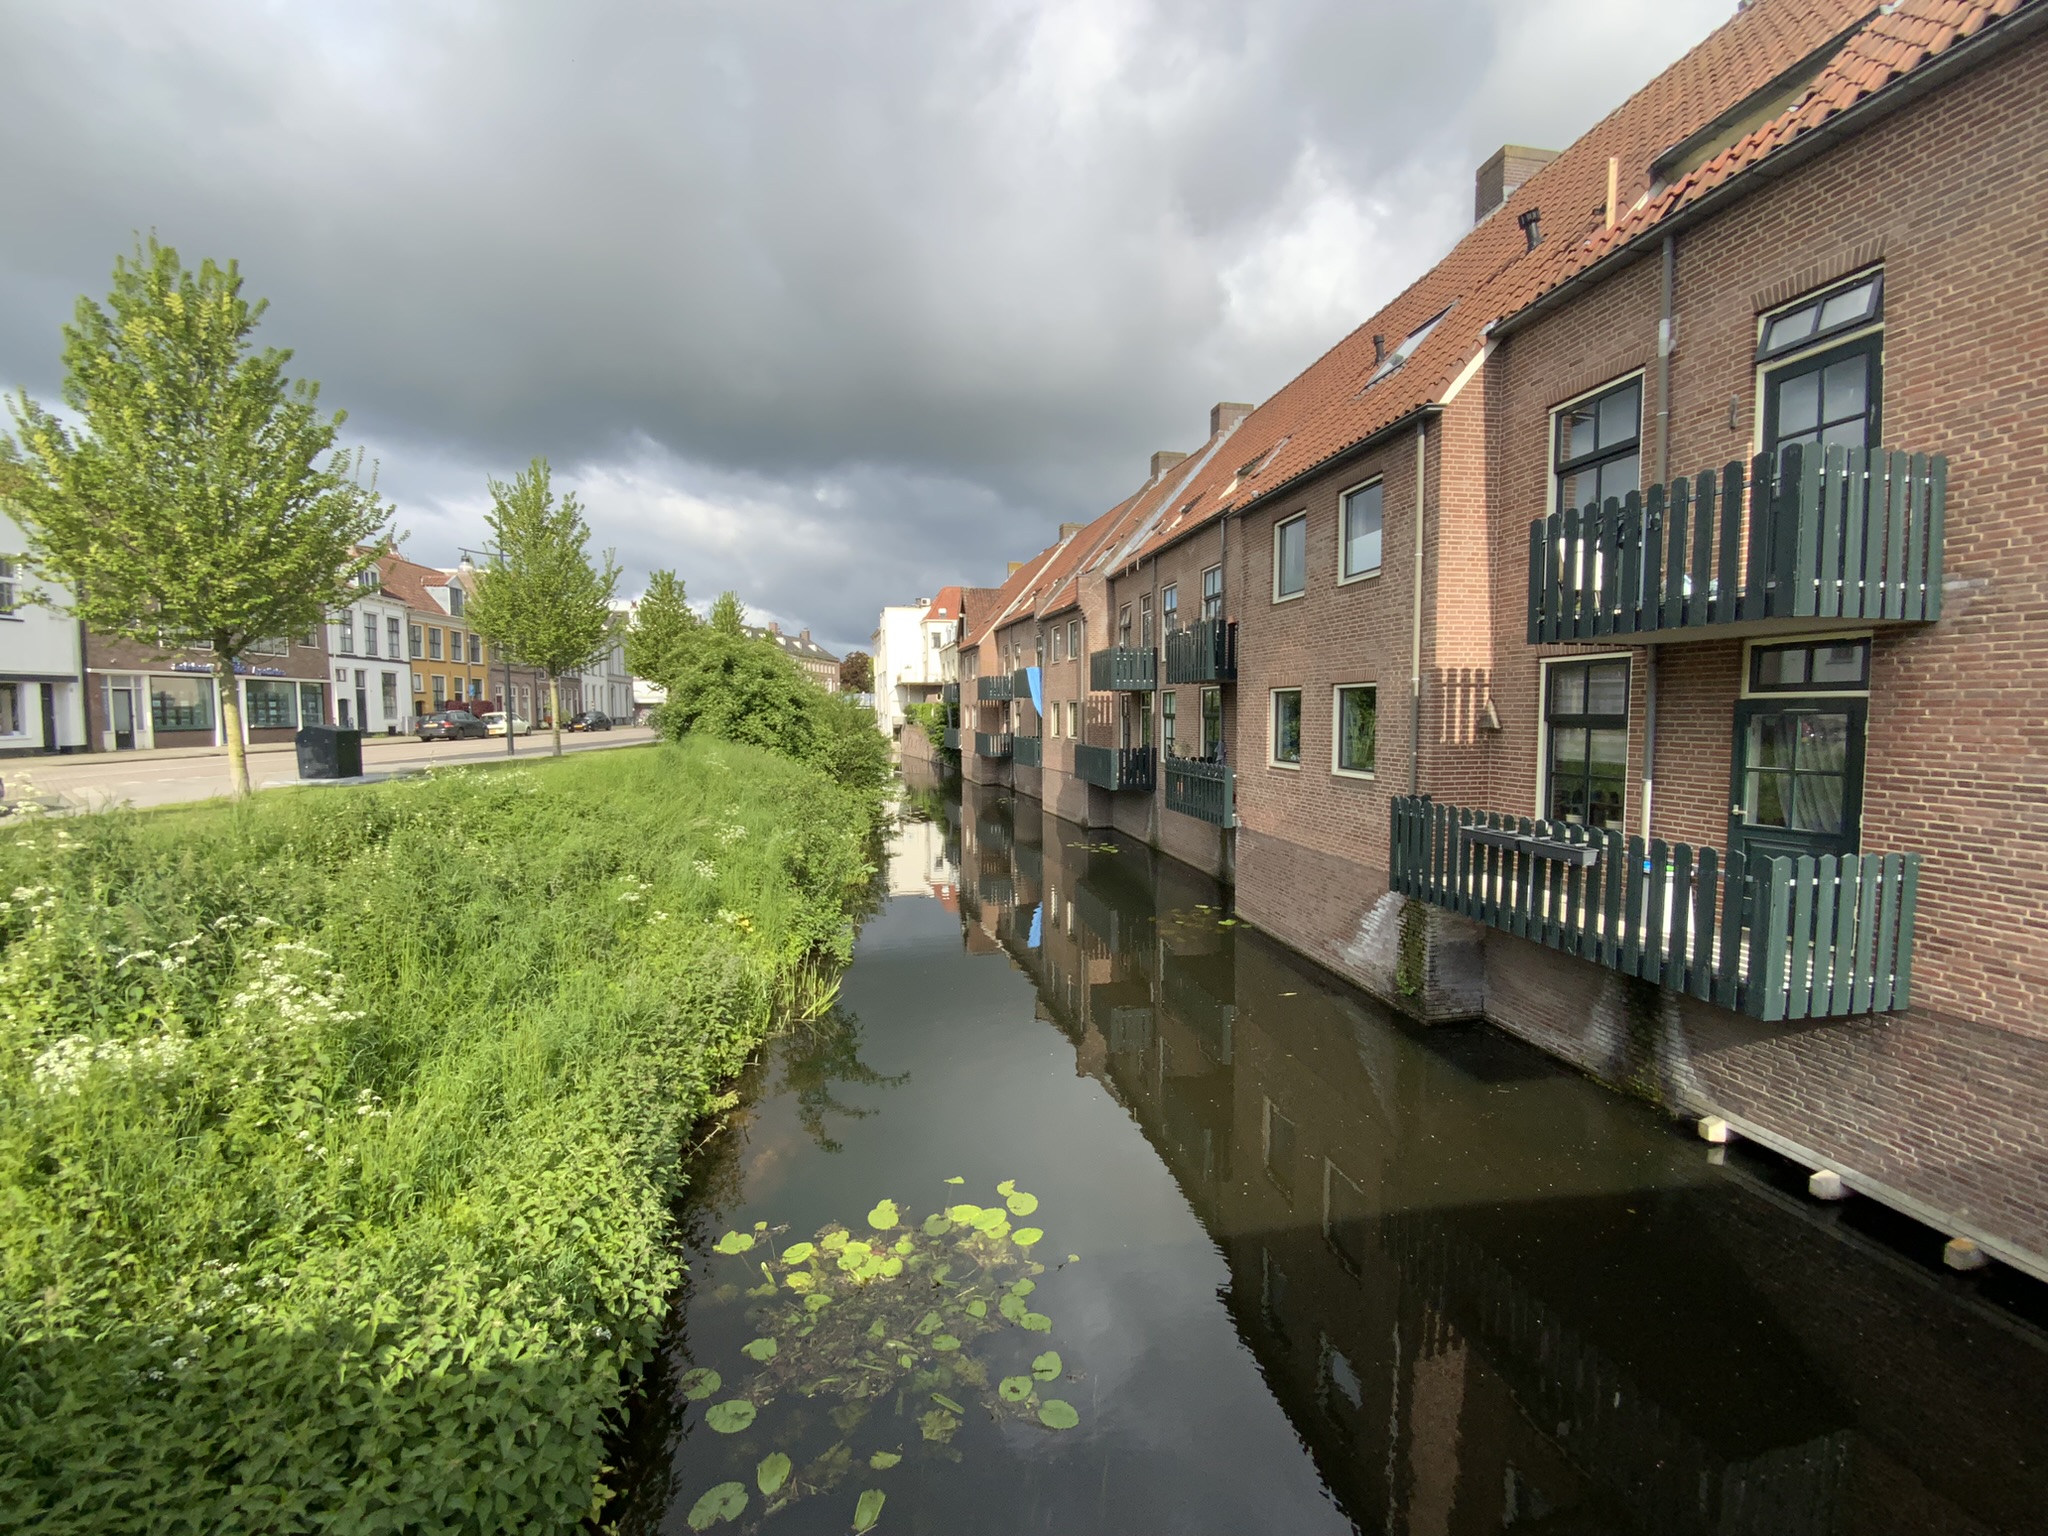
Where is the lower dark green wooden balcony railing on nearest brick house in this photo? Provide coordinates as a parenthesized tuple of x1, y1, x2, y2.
(1389, 797, 1921, 1020)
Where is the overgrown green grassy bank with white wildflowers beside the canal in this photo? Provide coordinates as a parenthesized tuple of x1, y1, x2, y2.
(0, 739, 872, 1532)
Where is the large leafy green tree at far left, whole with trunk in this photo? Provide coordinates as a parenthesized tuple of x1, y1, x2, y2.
(0, 238, 389, 799)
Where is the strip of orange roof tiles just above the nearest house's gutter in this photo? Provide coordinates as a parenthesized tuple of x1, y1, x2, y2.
(1528, 0, 2030, 313)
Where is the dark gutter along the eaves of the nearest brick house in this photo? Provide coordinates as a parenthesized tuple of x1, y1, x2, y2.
(1491, 0, 2048, 336)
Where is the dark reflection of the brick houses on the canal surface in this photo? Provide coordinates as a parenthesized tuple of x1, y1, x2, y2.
(948, 784, 2048, 1536)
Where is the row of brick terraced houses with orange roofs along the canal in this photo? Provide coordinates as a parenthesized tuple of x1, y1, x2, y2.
(921, 0, 2048, 1278)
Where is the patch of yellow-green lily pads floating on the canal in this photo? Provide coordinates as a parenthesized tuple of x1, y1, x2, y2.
(678, 1178, 1081, 1530)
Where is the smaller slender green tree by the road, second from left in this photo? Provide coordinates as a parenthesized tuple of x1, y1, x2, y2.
(469, 459, 618, 758)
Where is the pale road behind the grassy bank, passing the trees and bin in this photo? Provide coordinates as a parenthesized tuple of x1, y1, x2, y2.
(0, 725, 655, 811)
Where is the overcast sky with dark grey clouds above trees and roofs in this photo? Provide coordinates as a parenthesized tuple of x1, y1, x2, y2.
(0, 0, 1733, 649)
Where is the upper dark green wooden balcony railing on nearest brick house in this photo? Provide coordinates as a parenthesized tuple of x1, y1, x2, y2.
(1528, 446, 1948, 645)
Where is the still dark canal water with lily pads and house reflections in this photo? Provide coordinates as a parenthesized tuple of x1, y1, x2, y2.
(610, 784, 2048, 1536)
